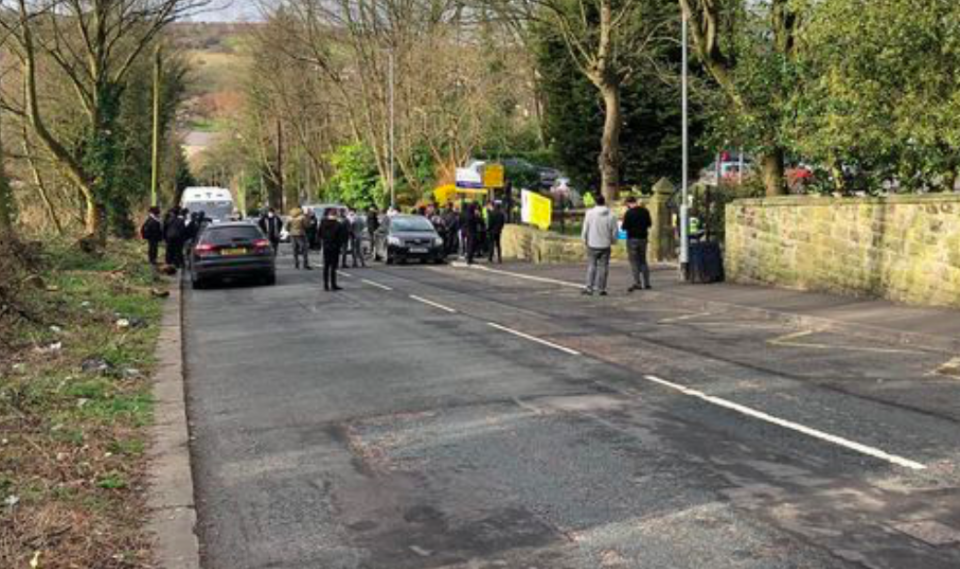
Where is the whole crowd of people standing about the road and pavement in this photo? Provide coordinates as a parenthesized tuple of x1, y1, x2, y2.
(140, 191, 652, 296)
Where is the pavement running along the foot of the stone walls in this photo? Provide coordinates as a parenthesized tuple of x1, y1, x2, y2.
(464, 263, 960, 354)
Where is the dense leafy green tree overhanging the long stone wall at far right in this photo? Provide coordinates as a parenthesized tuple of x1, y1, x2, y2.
(792, 0, 960, 192)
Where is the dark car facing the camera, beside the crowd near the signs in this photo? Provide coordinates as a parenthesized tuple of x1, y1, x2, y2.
(377, 215, 446, 265)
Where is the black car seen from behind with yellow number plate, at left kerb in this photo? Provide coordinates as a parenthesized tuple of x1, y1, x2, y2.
(189, 221, 277, 289)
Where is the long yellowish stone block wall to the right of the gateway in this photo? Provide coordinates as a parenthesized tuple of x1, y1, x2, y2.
(725, 194, 960, 307)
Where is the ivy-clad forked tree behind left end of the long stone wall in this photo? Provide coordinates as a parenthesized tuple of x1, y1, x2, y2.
(679, 0, 801, 196)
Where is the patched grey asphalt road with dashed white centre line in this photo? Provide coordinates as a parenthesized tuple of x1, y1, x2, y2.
(184, 251, 960, 569)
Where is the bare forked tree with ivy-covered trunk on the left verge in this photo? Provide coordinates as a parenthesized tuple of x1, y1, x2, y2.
(14, 0, 206, 243)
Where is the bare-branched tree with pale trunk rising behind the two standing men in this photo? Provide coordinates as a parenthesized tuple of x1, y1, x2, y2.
(506, 0, 676, 200)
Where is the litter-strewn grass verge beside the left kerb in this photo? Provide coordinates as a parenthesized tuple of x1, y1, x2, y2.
(0, 241, 162, 569)
